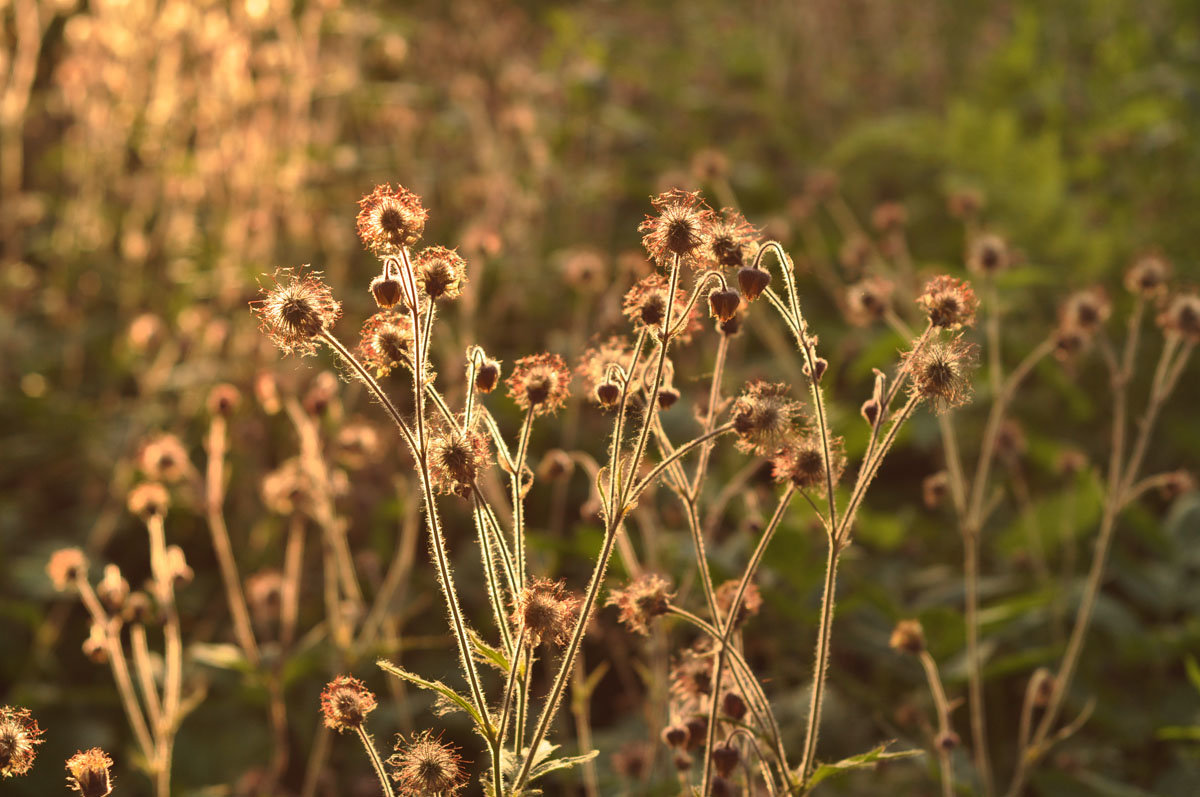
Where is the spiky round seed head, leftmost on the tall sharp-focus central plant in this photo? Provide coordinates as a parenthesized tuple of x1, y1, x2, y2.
(250, 265, 342, 356)
